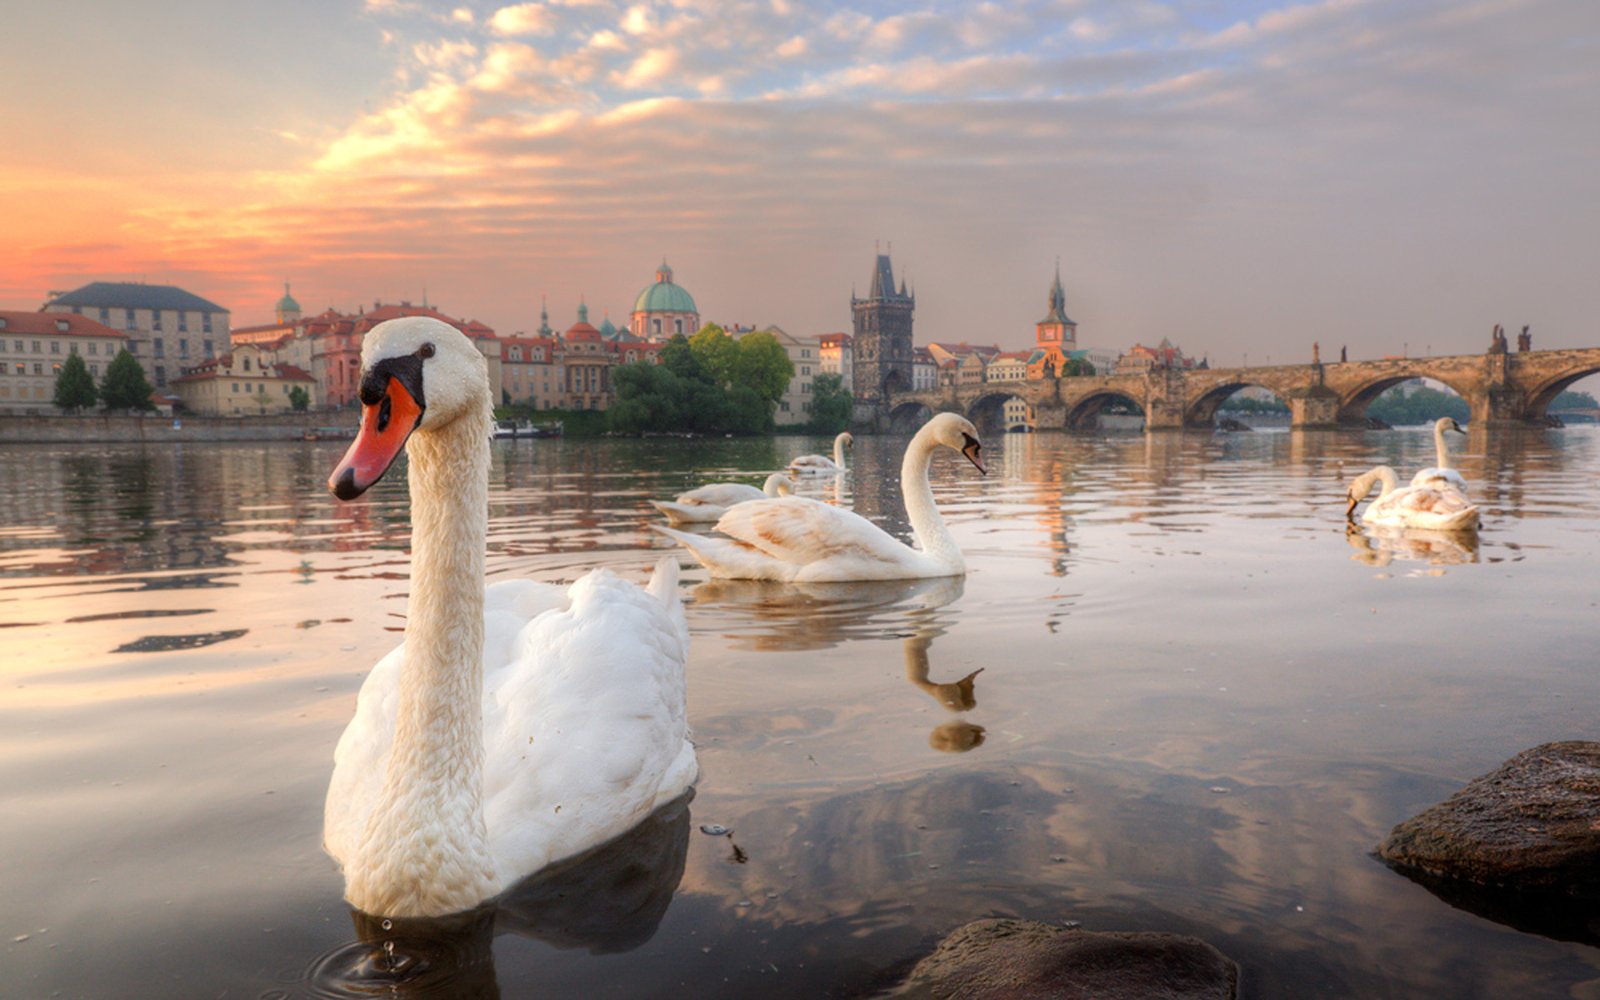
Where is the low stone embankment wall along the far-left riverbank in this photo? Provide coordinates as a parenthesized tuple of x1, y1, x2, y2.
(0, 413, 357, 445)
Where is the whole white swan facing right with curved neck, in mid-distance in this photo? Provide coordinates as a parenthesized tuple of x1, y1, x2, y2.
(654, 413, 987, 582)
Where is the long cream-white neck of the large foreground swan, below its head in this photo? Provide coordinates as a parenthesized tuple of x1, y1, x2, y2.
(346, 405, 496, 917)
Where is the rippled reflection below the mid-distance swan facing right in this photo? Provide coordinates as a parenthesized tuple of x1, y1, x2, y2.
(694, 576, 984, 754)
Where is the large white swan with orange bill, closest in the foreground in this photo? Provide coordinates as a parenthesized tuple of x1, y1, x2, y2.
(323, 317, 698, 917)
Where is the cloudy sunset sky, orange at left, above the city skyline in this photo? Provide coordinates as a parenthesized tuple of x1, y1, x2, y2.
(0, 0, 1600, 365)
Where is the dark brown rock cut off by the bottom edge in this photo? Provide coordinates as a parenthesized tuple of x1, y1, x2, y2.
(890, 920, 1238, 1000)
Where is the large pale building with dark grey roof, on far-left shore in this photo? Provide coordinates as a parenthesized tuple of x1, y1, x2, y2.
(43, 282, 229, 389)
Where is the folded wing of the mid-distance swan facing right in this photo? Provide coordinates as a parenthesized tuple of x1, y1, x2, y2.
(717, 496, 907, 565)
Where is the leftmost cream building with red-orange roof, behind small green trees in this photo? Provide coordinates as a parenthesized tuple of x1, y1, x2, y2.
(0, 310, 128, 413)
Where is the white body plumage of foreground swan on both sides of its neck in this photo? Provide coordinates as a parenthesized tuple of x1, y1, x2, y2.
(323, 558, 698, 890)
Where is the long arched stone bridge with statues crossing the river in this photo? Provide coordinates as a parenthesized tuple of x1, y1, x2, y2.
(854, 347, 1600, 432)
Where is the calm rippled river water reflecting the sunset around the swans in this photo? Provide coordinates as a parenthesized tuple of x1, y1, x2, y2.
(0, 429, 1600, 998)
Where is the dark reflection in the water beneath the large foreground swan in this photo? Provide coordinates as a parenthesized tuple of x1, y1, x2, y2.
(309, 789, 694, 1000)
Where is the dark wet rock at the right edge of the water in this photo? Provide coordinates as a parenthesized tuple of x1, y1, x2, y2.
(1378, 741, 1600, 896)
